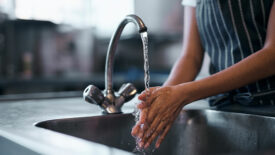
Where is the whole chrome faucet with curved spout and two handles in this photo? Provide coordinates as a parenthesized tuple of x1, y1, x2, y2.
(83, 15, 147, 114)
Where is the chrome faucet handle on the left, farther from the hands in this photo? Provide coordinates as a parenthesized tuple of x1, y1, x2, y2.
(83, 85, 104, 105)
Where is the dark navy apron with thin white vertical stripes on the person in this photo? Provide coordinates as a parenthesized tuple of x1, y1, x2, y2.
(196, 0, 275, 106)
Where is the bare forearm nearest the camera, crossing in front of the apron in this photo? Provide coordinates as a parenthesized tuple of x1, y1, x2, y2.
(181, 48, 275, 102)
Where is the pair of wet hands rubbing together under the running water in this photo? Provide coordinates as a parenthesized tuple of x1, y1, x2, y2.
(132, 86, 192, 148)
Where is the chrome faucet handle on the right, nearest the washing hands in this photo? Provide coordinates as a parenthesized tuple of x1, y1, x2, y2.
(118, 83, 137, 102)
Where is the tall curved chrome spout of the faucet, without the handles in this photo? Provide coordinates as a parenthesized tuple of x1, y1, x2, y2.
(105, 15, 147, 100)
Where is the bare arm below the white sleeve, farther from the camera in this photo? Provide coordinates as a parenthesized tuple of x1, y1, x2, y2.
(163, 7, 204, 86)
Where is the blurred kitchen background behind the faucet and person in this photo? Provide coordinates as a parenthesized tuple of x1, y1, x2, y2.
(0, 0, 203, 99)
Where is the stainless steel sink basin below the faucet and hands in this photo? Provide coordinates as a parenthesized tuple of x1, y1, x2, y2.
(36, 110, 275, 155)
